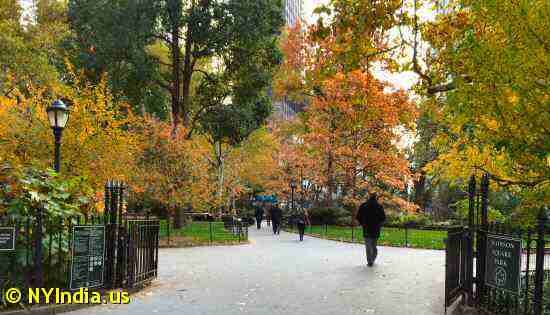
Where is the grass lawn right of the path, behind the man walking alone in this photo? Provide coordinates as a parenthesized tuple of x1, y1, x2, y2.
(288, 225, 447, 249)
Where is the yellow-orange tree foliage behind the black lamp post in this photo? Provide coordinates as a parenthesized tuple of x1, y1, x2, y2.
(0, 75, 137, 189)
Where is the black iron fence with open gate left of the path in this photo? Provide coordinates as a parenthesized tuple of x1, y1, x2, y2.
(0, 182, 160, 303)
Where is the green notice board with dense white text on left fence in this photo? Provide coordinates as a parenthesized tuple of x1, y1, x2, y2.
(70, 225, 105, 290)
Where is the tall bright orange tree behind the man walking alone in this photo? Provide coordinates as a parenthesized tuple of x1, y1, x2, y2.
(275, 14, 416, 215)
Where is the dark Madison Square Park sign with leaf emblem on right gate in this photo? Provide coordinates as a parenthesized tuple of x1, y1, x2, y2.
(485, 234, 521, 294)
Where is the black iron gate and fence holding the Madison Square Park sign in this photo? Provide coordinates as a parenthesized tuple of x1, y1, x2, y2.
(445, 173, 550, 315)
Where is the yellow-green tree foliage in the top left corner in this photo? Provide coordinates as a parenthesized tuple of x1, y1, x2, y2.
(0, 0, 69, 97)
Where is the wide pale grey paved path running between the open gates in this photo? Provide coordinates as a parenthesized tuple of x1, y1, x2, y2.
(70, 227, 445, 315)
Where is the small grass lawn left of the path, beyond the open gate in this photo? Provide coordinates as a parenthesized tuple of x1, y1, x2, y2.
(160, 220, 247, 247)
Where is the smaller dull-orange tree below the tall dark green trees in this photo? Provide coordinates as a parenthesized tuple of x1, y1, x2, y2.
(133, 116, 215, 218)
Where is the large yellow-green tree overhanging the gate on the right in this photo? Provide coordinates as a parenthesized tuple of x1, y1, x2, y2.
(412, 0, 550, 209)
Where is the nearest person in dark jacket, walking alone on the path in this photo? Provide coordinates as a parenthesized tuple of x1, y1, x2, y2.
(357, 194, 386, 267)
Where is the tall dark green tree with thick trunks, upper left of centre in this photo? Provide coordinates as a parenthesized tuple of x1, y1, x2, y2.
(70, 0, 283, 133)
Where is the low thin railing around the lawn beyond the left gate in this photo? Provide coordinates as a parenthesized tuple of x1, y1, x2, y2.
(160, 218, 248, 247)
